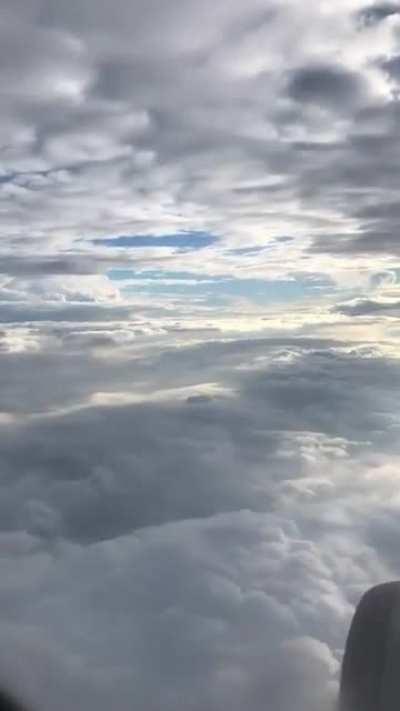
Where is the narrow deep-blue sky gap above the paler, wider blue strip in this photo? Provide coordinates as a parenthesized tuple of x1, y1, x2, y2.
(93, 231, 218, 251)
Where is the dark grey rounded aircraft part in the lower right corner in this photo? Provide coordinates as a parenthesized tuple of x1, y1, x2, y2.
(339, 582, 400, 711)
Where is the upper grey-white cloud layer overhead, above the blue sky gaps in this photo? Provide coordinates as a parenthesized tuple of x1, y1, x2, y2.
(0, 0, 398, 290)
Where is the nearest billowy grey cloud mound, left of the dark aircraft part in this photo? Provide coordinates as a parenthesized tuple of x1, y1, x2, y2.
(1, 512, 346, 710)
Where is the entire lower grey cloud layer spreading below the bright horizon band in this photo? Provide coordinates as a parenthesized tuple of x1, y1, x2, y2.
(0, 338, 399, 711)
